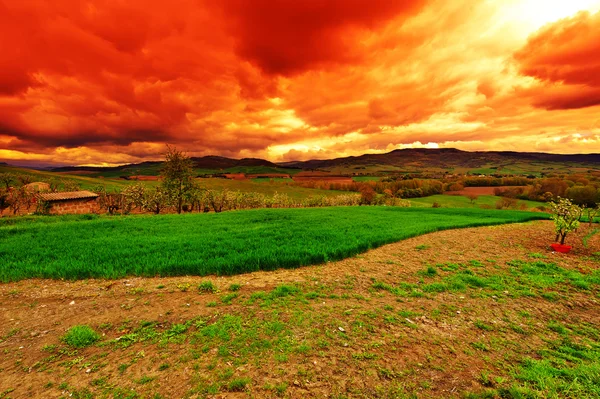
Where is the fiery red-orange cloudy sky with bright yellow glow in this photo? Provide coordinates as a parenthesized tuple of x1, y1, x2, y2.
(0, 0, 600, 165)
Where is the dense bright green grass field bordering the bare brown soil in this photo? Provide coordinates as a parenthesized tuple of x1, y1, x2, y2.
(0, 207, 547, 282)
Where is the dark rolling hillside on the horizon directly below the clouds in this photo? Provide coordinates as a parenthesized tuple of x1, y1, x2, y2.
(8, 148, 600, 177)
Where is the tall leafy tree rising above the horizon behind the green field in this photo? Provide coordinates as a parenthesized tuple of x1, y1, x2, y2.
(161, 146, 194, 213)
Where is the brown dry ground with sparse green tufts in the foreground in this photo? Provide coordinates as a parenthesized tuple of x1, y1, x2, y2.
(0, 222, 600, 398)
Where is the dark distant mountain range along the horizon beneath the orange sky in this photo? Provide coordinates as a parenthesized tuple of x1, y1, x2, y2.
(7, 148, 600, 173)
